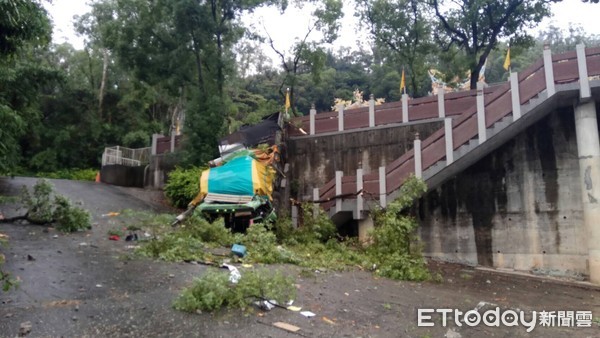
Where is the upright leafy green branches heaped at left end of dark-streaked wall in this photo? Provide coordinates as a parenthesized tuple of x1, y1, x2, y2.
(367, 176, 430, 280)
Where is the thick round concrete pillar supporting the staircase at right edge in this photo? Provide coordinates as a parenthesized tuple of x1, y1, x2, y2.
(575, 101, 600, 284)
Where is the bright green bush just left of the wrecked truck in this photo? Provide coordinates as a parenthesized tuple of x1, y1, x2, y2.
(164, 167, 205, 208)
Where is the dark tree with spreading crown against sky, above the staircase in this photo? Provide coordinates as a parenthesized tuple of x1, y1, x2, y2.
(428, 0, 552, 89)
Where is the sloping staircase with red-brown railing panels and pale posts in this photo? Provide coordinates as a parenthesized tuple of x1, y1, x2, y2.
(319, 46, 600, 220)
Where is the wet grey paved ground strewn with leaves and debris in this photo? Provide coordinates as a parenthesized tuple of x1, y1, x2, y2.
(0, 178, 600, 338)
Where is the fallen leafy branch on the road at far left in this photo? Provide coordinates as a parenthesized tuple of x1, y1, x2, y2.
(21, 179, 91, 232)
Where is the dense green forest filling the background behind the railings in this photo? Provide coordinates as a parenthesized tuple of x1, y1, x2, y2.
(0, 0, 600, 174)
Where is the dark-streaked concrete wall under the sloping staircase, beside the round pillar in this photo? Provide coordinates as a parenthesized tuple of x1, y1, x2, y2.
(418, 108, 587, 274)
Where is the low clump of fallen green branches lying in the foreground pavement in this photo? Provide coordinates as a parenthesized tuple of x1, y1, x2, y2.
(174, 270, 296, 312)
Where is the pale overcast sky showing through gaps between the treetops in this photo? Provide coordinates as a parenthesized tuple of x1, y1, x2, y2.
(45, 0, 600, 57)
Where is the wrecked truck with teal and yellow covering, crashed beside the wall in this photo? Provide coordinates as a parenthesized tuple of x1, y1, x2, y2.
(183, 145, 279, 232)
